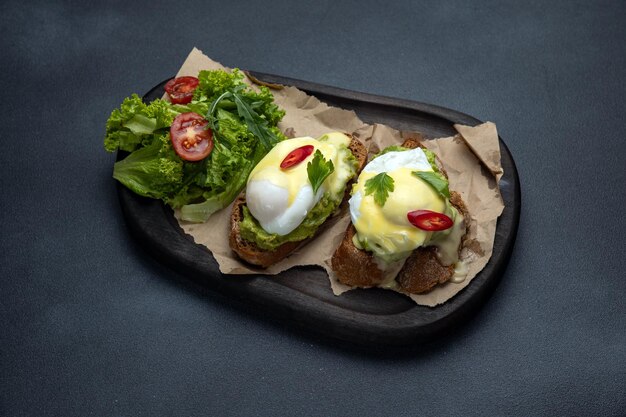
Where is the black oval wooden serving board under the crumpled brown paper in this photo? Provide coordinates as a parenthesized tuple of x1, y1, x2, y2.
(118, 72, 521, 345)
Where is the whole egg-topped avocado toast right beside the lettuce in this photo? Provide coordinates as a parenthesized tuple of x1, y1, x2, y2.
(229, 132, 367, 268)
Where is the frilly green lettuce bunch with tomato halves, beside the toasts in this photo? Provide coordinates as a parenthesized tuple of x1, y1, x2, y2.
(104, 69, 285, 222)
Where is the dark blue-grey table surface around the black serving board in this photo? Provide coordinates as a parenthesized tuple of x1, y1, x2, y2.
(0, 0, 626, 416)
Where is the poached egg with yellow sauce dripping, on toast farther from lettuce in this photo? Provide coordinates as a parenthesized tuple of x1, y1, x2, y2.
(349, 148, 464, 269)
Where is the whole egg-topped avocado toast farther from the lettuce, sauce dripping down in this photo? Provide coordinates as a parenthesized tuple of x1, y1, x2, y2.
(332, 139, 467, 294)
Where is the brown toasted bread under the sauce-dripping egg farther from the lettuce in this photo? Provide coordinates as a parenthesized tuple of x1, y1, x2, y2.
(331, 138, 468, 294)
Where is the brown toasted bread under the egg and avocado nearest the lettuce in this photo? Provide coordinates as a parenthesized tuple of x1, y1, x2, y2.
(229, 135, 367, 268)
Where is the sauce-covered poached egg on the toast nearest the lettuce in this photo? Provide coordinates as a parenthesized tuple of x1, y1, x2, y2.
(246, 132, 353, 236)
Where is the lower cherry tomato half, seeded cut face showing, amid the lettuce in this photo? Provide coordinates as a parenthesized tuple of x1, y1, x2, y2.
(170, 112, 213, 162)
